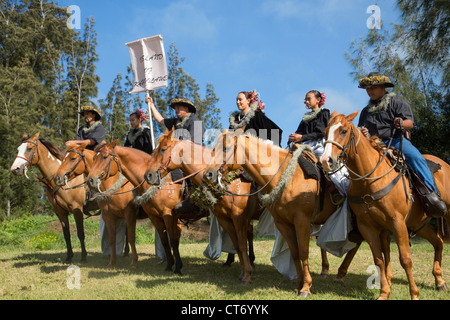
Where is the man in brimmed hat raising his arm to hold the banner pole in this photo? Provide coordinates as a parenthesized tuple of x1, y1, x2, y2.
(145, 96, 205, 215)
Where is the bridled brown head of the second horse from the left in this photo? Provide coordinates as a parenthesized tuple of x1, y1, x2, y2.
(55, 142, 88, 186)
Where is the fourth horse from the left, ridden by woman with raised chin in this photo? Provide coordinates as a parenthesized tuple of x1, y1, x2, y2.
(145, 130, 264, 284)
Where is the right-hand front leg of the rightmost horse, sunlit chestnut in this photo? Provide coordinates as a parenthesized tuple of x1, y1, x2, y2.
(391, 220, 419, 300)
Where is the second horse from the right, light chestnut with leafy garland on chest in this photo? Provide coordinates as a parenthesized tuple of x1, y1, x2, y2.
(203, 129, 336, 297)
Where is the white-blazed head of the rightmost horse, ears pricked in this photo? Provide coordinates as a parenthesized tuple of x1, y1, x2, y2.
(320, 111, 359, 172)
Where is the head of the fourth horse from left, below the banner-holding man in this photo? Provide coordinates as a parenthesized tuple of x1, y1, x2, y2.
(144, 129, 179, 185)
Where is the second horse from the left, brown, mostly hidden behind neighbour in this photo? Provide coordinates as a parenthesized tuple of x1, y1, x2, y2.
(55, 143, 139, 268)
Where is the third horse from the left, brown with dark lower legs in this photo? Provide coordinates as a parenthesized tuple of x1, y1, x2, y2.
(87, 140, 183, 274)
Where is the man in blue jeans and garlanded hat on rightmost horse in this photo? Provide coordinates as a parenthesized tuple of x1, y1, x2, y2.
(358, 72, 447, 216)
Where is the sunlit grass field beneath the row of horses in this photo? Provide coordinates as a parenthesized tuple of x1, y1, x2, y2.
(0, 214, 450, 300)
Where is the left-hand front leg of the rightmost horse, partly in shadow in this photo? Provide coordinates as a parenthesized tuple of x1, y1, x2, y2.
(358, 219, 391, 300)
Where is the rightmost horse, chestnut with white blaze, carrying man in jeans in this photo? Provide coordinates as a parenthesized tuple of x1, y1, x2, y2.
(321, 112, 450, 299)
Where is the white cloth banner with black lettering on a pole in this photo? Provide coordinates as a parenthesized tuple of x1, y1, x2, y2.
(126, 35, 168, 94)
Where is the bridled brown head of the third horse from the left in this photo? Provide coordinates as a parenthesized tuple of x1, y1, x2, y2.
(87, 140, 120, 190)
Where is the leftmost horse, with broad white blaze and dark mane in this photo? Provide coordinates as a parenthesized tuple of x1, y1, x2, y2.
(11, 132, 87, 262)
